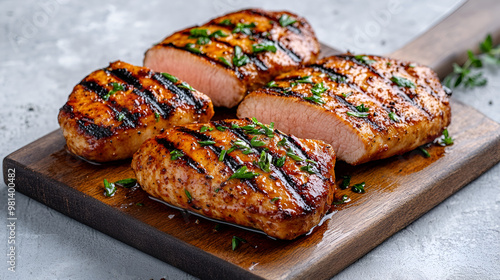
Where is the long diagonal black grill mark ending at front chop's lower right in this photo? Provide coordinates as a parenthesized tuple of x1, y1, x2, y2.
(219, 121, 313, 212)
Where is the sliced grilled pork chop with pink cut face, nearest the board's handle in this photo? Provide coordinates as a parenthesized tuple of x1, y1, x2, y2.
(237, 54, 451, 165)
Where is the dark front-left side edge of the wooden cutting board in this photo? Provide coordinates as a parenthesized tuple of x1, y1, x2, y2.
(3, 156, 263, 279)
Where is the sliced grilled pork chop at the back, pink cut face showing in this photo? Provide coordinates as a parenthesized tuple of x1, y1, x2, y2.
(144, 9, 319, 108)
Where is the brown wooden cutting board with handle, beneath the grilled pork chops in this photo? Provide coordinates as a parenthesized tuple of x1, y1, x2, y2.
(3, 0, 500, 279)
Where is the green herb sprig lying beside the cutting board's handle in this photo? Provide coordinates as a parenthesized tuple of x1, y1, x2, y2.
(443, 34, 500, 88)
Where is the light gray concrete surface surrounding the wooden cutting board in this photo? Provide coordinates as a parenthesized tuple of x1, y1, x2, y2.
(0, 0, 500, 279)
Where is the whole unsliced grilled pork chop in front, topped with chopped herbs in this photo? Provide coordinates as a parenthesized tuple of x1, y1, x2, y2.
(132, 119, 335, 239)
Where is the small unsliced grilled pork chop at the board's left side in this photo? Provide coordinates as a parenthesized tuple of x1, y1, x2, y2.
(58, 61, 214, 162)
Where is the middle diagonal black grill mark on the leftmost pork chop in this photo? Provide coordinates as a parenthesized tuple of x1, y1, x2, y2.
(104, 68, 177, 119)
